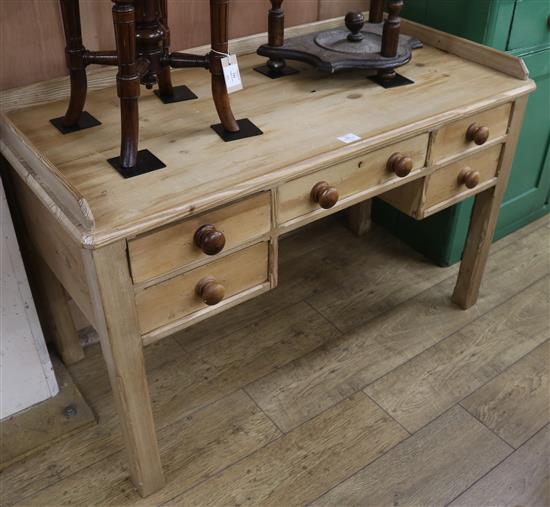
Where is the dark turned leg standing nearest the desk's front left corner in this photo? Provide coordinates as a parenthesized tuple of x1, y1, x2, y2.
(113, 0, 139, 168)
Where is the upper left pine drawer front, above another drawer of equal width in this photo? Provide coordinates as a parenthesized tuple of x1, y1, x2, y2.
(128, 192, 271, 283)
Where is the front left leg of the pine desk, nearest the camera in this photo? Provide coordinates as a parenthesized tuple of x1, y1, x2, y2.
(88, 241, 164, 496)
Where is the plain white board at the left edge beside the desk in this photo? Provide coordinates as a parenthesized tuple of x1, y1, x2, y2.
(0, 179, 59, 419)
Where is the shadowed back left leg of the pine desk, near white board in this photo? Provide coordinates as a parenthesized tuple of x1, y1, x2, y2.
(33, 255, 84, 366)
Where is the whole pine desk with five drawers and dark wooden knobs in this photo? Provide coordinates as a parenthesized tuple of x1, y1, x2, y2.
(1, 14, 534, 495)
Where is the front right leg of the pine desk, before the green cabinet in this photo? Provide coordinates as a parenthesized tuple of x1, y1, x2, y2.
(453, 96, 527, 310)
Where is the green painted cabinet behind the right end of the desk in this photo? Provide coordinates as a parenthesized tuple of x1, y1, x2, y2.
(373, 0, 550, 266)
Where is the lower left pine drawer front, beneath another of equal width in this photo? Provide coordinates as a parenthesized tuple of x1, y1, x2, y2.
(136, 242, 269, 333)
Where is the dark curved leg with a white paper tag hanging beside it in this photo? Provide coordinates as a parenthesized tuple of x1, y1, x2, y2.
(210, 0, 239, 132)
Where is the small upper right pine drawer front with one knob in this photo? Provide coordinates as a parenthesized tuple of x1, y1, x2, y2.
(431, 104, 512, 163)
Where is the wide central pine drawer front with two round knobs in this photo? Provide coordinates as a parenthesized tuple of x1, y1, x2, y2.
(278, 134, 428, 224)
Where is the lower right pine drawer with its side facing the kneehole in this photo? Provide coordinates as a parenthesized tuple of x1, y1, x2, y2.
(380, 144, 503, 219)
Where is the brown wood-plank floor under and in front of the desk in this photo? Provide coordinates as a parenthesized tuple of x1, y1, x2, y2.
(0, 212, 550, 507)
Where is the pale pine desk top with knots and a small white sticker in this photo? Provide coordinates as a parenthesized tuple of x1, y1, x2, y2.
(3, 22, 534, 246)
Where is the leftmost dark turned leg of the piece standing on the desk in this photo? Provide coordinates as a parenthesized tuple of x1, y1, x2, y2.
(60, 0, 88, 127)
